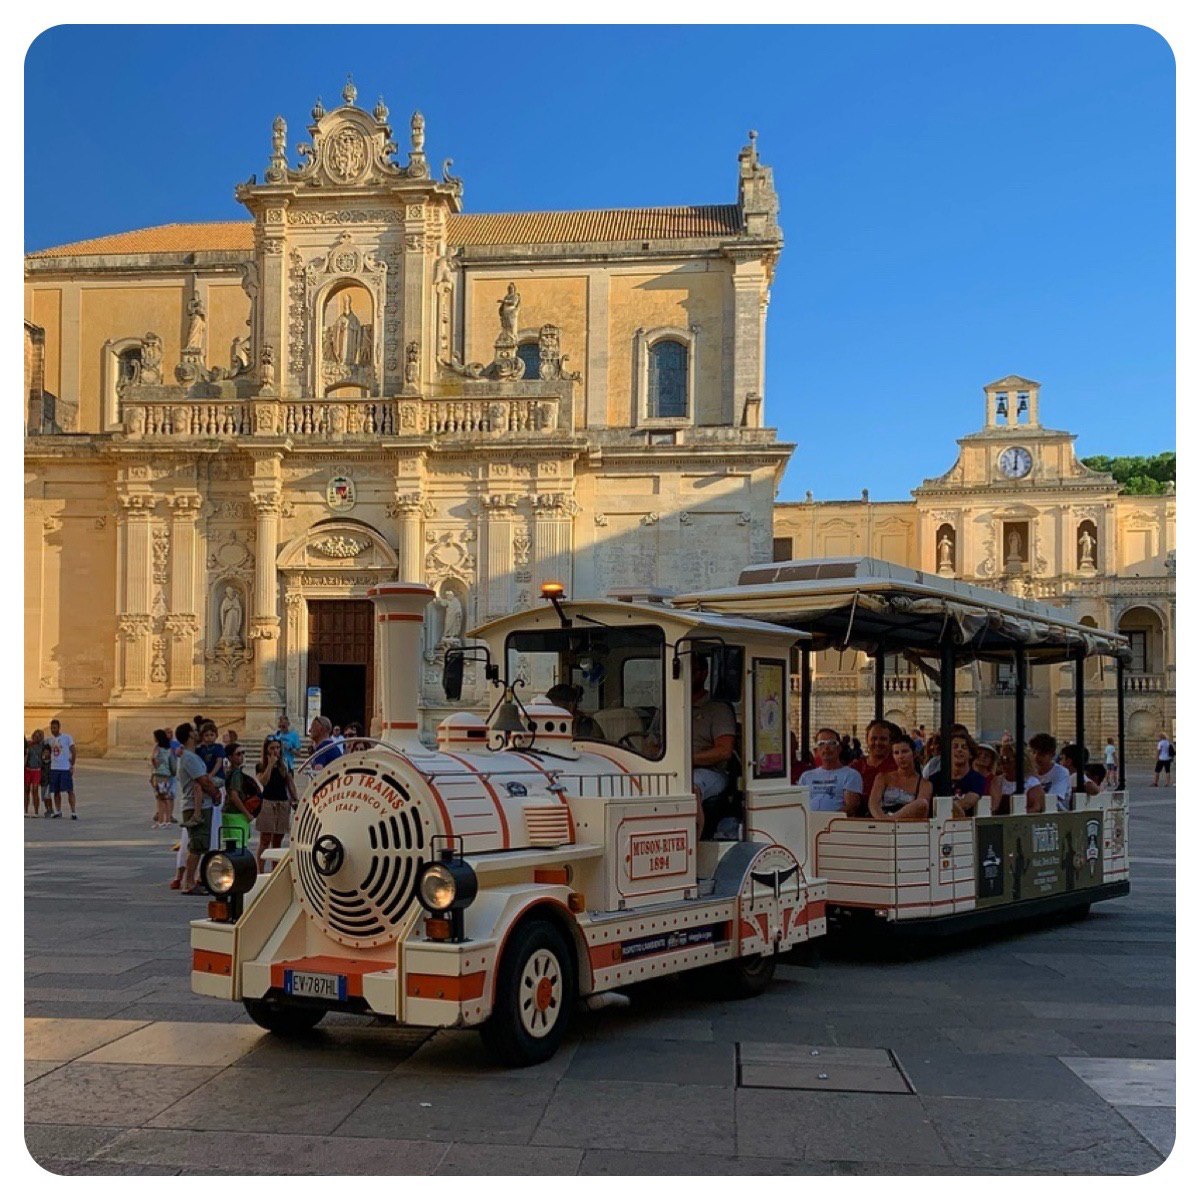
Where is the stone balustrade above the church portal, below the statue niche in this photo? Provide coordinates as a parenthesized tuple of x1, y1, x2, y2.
(121, 396, 561, 440)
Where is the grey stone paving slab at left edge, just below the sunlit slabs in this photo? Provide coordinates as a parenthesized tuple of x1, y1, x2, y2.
(25, 1063, 216, 1127)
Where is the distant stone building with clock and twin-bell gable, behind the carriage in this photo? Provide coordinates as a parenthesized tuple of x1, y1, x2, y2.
(774, 376, 1176, 763)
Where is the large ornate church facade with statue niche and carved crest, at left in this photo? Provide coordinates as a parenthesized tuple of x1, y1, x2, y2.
(25, 84, 792, 754)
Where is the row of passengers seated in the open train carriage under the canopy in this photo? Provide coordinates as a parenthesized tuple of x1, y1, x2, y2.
(792, 720, 1161, 821)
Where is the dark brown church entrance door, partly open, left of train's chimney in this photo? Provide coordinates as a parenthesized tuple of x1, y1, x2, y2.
(308, 600, 374, 731)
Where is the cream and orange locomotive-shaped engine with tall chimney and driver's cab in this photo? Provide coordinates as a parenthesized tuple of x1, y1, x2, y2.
(192, 583, 826, 1064)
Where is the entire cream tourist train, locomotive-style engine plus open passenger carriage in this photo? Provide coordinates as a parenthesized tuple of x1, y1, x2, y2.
(192, 559, 1129, 1064)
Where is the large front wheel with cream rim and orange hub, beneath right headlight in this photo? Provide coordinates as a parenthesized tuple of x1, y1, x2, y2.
(479, 920, 577, 1067)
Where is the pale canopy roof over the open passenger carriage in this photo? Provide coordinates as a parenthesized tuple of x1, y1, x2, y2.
(672, 558, 1129, 662)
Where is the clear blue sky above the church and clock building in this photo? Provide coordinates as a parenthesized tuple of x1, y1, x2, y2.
(25, 25, 1175, 499)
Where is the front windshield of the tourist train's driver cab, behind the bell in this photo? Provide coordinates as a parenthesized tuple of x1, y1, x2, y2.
(505, 625, 666, 758)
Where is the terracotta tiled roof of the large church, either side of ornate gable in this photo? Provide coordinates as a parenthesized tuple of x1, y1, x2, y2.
(29, 204, 742, 258)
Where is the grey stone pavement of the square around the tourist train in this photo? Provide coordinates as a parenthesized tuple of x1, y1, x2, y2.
(25, 762, 1175, 1175)
